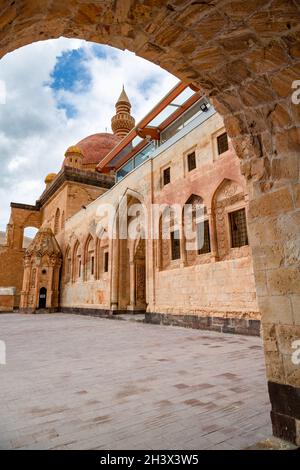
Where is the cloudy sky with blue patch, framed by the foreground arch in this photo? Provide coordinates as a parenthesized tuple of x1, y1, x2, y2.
(0, 38, 177, 230)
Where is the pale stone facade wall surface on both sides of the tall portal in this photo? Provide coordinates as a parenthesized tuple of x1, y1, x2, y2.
(61, 114, 260, 319)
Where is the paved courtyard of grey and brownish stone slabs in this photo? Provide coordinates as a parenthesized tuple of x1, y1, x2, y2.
(0, 314, 271, 449)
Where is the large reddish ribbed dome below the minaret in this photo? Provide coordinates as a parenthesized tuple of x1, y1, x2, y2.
(76, 132, 120, 165)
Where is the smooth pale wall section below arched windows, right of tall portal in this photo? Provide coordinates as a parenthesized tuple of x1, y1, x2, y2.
(154, 257, 260, 320)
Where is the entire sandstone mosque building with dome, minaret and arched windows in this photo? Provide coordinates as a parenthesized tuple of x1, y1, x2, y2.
(0, 82, 260, 335)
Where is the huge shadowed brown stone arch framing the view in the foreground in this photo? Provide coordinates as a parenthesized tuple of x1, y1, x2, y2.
(0, 0, 300, 443)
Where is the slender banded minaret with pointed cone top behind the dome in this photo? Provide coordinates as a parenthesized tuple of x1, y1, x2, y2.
(111, 85, 135, 139)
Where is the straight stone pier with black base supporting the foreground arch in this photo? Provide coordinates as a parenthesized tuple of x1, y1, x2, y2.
(248, 183, 300, 445)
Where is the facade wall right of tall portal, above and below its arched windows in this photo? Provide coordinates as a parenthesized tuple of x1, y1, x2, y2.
(148, 114, 260, 319)
